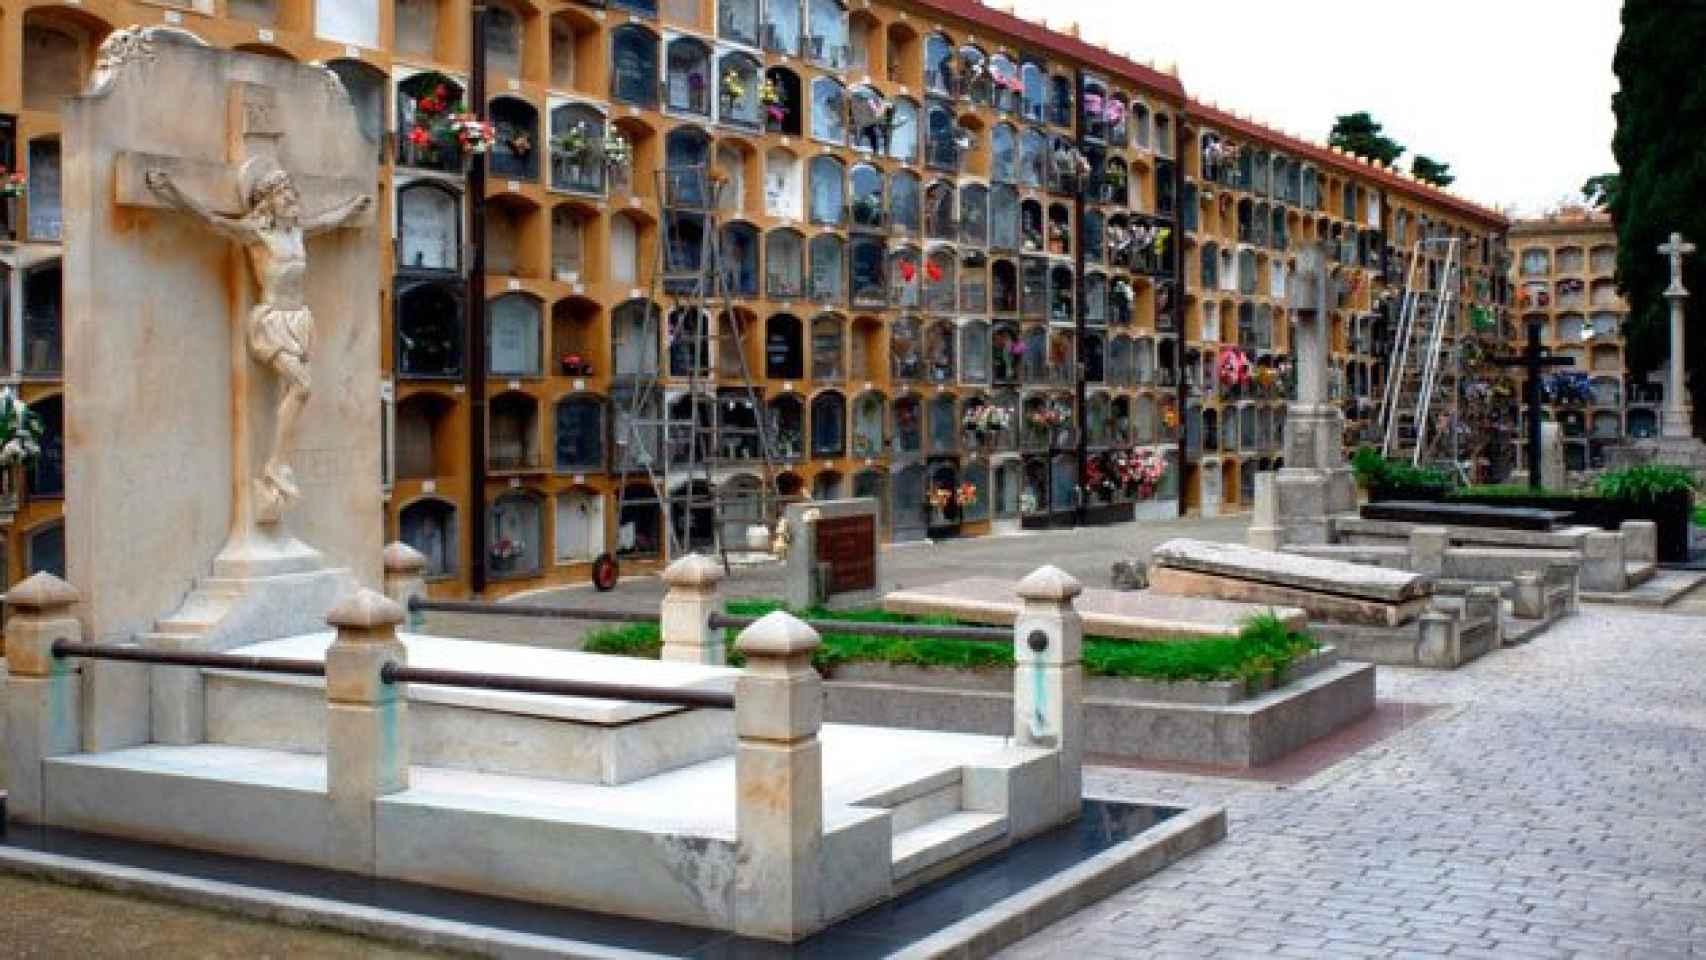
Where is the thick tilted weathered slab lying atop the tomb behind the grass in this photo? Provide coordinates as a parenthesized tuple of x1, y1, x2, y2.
(1150, 539, 1433, 604)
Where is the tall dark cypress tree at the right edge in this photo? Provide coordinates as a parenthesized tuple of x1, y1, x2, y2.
(1610, 0, 1706, 433)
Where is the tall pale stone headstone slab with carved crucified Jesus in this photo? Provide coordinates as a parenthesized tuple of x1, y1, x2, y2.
(63, 27, 384, 743)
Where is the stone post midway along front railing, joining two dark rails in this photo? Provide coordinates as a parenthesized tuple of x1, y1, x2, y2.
(326, 590, 409, 873)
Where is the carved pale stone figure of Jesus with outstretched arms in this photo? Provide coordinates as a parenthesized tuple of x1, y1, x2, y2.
(145, 155, 374, 523)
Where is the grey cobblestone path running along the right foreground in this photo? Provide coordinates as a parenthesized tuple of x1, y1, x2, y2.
(1001, 604, 1706, 960)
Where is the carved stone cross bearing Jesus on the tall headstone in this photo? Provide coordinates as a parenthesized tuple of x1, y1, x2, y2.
(116, 82, 372, 541)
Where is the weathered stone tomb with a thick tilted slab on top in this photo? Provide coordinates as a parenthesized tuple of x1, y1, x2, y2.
(1150, 539, 1501, 667)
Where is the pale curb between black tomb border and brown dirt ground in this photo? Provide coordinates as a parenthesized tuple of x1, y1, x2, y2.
(0, 846, 660, 960)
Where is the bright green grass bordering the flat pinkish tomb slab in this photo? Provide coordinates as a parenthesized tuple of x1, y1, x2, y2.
(585, 600, 1320, 682)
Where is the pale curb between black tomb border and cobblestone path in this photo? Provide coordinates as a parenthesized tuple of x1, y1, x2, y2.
(891, 800, 1227, 960)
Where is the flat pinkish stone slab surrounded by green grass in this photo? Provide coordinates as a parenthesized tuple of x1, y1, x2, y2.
(882, 576, 1309, 639)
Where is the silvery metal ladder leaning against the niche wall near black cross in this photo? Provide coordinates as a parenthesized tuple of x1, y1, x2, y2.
(1375, 237, 1459, 467)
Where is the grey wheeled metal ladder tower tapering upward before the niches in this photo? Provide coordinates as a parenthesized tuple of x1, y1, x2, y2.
(611, 167, 784, 570)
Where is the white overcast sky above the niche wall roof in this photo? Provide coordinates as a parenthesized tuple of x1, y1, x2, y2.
(993, 0, 1621, 213)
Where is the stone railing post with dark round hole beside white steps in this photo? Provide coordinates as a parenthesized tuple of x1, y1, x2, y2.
(1013, 566, 1083, 820)
